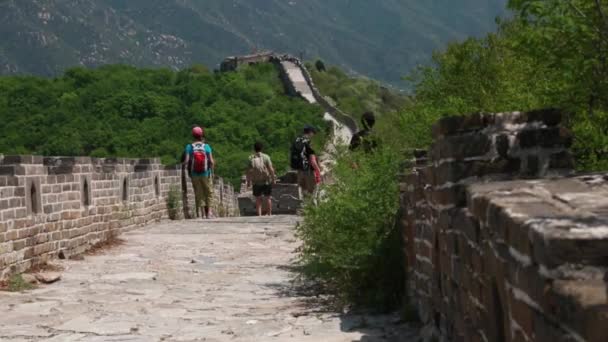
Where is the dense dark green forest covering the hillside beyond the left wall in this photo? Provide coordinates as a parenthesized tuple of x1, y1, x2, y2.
(0, 64, 325, 184)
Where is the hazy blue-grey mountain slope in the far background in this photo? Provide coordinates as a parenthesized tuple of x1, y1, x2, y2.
(0, 0, 507, 82)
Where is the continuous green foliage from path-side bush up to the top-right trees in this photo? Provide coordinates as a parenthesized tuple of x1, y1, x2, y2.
(298, 0, 608, 309)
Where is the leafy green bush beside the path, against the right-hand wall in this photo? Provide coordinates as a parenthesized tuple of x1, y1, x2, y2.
(297, 149, 404, 310)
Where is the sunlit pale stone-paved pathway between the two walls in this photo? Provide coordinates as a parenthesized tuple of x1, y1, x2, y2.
(0, 217, 417, 342)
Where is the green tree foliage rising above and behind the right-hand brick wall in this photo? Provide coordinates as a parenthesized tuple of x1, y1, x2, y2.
(380, 0, 608, 171)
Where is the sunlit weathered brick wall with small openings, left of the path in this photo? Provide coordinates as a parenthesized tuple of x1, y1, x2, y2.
(0, 156, 238, 278)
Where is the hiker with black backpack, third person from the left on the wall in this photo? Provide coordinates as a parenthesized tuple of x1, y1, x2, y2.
(290, 125, 321, 195)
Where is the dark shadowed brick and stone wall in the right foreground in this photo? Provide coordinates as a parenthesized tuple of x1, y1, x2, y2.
(401, 110, 608, 342)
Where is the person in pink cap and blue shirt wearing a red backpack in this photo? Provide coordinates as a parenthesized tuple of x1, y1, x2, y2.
(184, 126, 215, 218)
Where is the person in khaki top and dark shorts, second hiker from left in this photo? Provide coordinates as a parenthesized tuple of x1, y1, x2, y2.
(247, 142, 276, 216)
